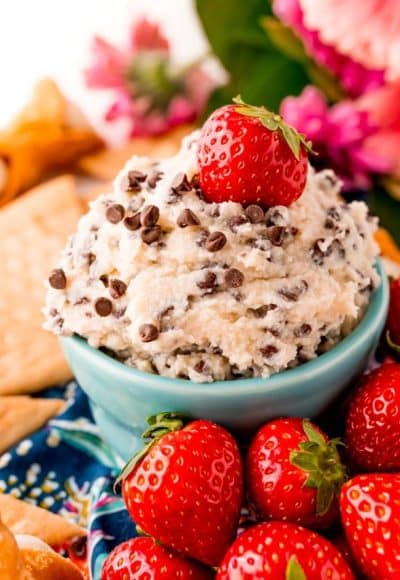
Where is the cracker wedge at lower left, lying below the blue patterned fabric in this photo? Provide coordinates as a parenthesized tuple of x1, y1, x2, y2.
(0, 493, 86, 546)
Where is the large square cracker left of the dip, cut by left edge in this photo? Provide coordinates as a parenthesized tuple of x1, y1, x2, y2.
(0, 176, 82, 395)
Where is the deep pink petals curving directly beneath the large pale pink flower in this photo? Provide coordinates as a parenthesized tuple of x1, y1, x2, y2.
(273, 0, 384, 97)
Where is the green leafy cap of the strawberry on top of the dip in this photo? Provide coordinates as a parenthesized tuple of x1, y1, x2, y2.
(233, 95, 314, 160)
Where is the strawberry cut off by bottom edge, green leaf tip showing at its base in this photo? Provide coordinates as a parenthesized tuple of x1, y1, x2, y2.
(217, 522, 354, 580)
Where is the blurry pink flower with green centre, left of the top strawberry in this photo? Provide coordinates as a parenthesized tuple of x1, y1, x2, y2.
(85, 18, 215, 137)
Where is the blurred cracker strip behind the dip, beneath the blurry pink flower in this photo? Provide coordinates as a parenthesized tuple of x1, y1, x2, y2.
(78, 125, 194, 181)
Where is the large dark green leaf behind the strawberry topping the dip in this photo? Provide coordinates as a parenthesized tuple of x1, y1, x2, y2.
(196, 0, 308, 114)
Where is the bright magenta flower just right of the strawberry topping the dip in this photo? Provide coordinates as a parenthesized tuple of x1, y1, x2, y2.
(281, 86, 391, 190)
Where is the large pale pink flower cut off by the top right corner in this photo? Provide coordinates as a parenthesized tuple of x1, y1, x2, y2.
(300, 0, 400, 80)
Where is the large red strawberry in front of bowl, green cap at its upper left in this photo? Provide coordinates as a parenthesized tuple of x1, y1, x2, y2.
(121, 413, 243, 566)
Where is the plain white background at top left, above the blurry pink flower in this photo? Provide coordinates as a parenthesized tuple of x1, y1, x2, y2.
(0, 0, 212, 132)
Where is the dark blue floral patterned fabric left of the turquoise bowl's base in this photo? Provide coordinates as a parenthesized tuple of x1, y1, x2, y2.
(0, 382, 136, 580)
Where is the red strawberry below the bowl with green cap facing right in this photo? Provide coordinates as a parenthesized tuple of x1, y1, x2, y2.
(247, 418, 345, 528)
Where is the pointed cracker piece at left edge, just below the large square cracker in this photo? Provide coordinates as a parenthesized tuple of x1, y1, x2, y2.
(0, 396, 65, 453)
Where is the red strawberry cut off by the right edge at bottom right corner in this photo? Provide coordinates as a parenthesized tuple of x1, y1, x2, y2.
(340, 473, 400, 580)
